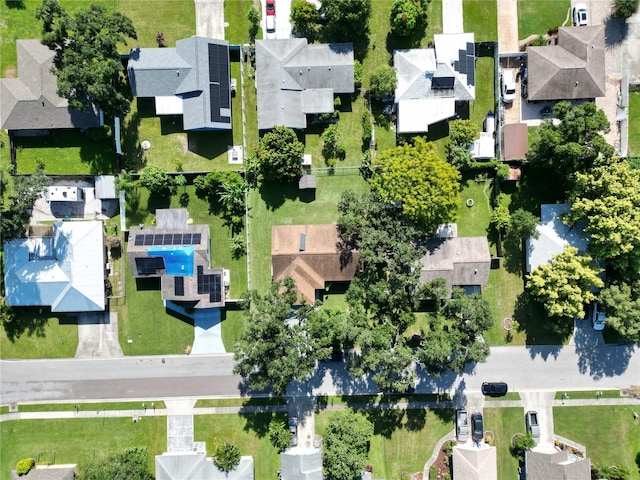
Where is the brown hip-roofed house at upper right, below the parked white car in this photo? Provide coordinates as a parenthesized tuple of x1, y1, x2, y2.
(527, 25, 606, 101)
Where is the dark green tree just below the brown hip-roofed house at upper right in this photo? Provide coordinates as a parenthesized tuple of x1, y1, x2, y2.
(527, 101, 614, 185)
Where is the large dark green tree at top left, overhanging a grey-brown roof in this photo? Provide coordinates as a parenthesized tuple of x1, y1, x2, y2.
(36, 0, 138, 117)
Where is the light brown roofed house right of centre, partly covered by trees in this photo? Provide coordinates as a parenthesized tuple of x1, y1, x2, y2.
(420, 223, 491, 293)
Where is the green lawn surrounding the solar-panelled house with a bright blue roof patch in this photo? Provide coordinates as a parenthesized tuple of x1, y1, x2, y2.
(118, 187, 247, 355)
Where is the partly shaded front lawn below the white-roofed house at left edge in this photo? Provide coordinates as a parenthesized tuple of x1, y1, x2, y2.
(0, 307, 78, 358)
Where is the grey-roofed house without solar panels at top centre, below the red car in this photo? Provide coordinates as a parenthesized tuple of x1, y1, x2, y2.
(256, 38, 355, 130)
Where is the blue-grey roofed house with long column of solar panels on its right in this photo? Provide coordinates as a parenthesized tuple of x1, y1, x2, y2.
(127, 37, 231, 131)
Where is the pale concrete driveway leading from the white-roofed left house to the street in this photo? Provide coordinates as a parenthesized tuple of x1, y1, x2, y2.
(76, 312, 123, 358)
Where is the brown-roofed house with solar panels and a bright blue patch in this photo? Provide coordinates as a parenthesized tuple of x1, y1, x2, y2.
(127, 208, 229, 309)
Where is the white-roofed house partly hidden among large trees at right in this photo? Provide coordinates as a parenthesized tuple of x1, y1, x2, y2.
(526, 203, 589, 273)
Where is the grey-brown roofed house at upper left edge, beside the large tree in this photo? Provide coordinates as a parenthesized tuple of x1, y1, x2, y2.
(0, 40, 104, 134)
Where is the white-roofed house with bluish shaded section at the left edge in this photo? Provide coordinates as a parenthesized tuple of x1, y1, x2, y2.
(4, 222, 105, 312)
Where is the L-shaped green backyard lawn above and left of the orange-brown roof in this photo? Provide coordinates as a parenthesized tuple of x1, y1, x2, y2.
(249, 170, 368, 291)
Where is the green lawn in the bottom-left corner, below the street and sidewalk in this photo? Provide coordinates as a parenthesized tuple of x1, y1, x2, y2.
(0, 417, 167, 480)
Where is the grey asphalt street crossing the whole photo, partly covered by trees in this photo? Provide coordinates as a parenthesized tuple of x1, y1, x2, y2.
(0, 345, 640, 404)
